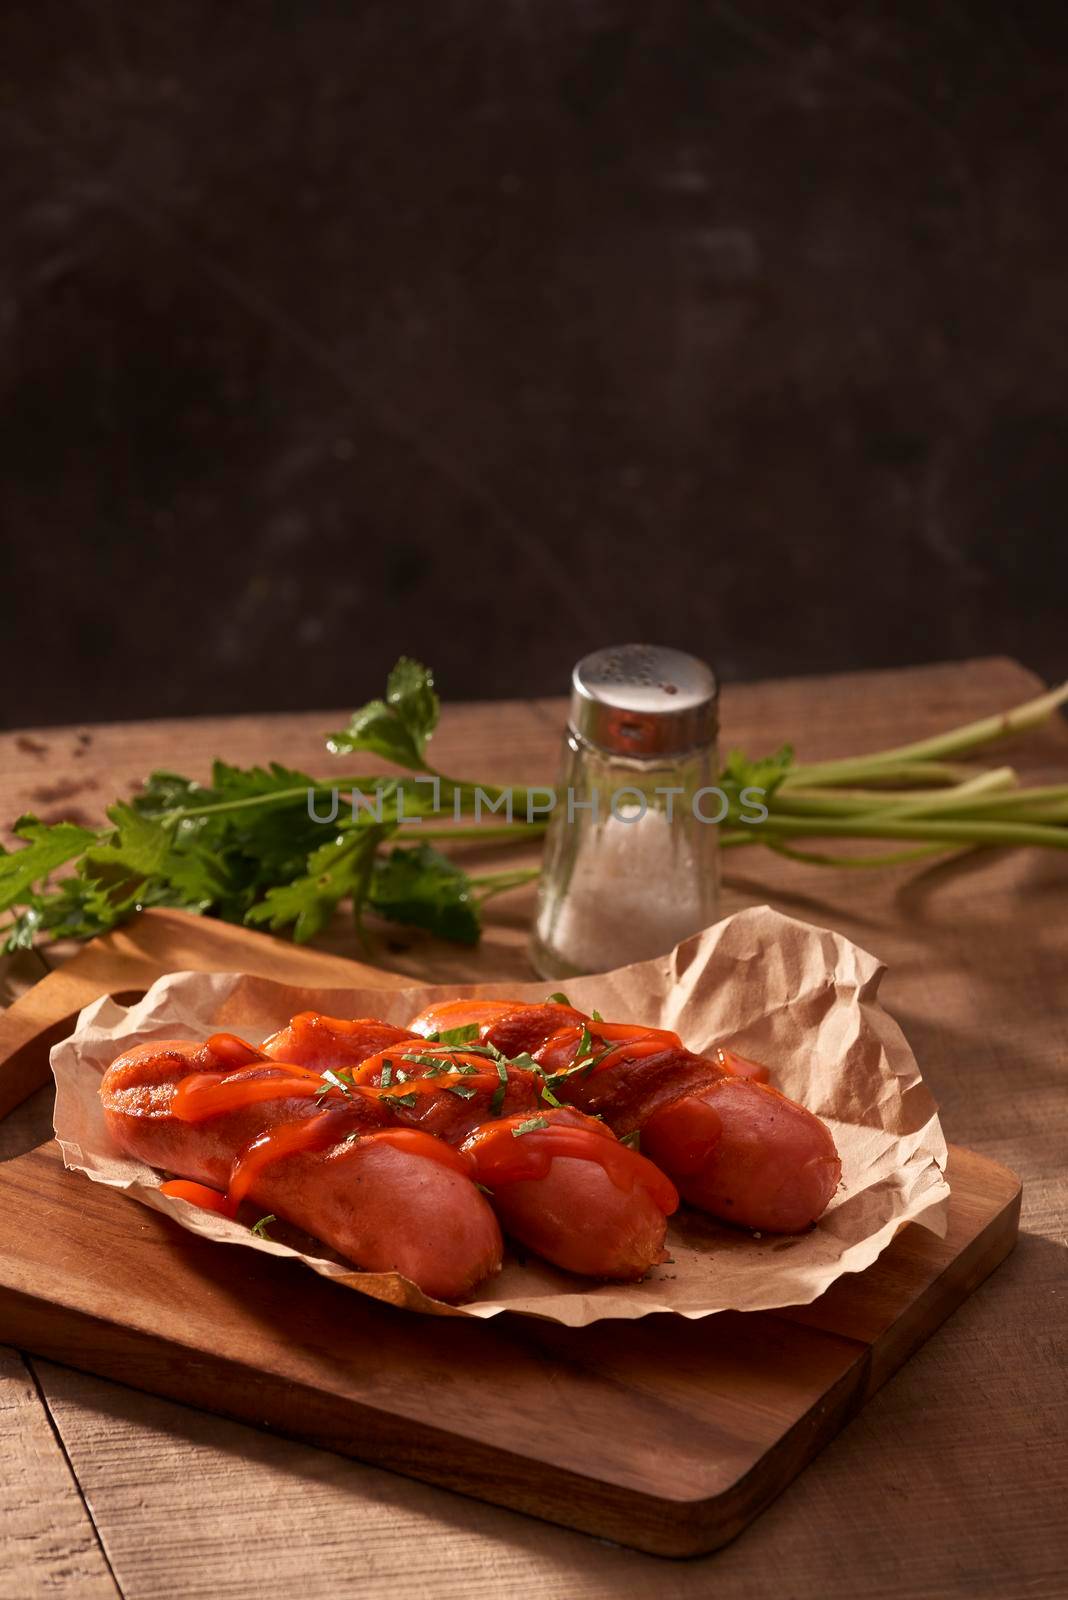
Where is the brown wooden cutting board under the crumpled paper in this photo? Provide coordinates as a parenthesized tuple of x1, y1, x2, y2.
(0, 912, 1020, 1555)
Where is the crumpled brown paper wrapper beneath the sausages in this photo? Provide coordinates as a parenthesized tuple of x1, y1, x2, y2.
(51, 906, 950, 1328)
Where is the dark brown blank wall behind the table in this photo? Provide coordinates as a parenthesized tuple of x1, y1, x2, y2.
(0, 0, 1068, 725)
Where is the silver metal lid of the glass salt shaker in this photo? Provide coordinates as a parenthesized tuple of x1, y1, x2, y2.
(571, 645, 719, 755)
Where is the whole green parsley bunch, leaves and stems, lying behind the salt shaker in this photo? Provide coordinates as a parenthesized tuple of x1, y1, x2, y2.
(0, 656, 1068, 950)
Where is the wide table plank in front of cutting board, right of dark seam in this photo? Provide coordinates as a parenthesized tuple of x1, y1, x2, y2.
(33, 1240, 1068, 1600)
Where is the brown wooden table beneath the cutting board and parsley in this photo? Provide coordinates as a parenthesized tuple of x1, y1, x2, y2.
(0, 661, 1068, 1600)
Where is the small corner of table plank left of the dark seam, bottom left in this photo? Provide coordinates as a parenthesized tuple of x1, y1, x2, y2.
(0, 1349, 118, 1600)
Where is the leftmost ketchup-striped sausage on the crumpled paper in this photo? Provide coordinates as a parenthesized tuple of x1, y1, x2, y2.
(101, 1034, 502, 1299)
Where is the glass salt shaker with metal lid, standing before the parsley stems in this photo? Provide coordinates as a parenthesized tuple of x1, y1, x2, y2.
(531, 645, 726, 978)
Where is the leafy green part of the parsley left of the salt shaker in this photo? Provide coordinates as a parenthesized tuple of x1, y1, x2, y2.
(0, 658, 544, 950)
